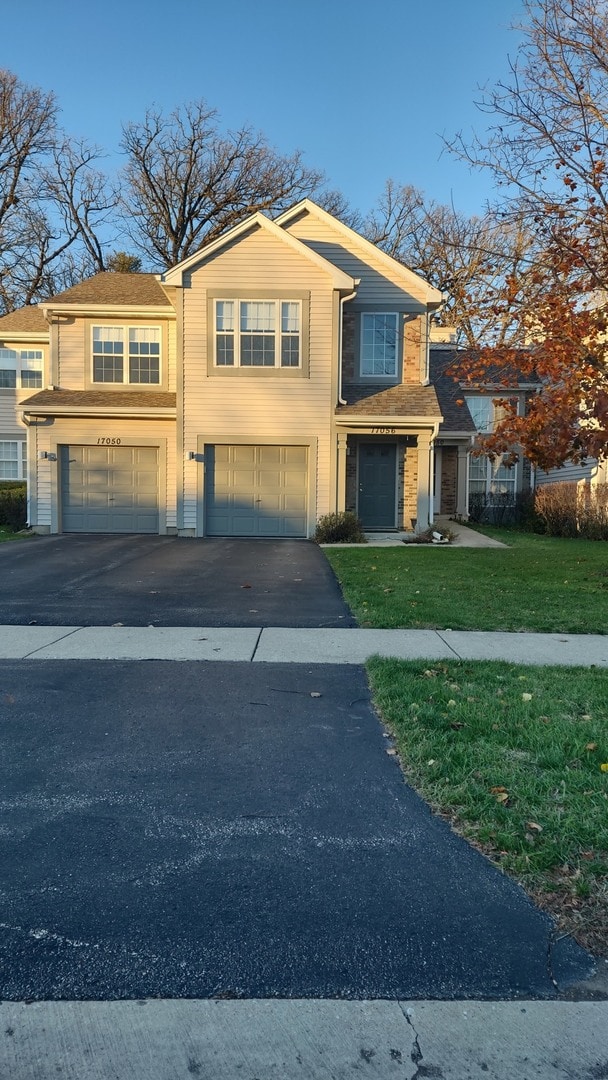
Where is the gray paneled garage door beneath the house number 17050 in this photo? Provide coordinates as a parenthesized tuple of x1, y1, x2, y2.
(60, 446, 159, 532)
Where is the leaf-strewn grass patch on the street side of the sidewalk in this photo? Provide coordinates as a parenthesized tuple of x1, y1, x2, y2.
(367, 658, 608, 957)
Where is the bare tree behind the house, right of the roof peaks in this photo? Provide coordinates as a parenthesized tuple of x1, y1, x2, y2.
(363, 180, 532, 347)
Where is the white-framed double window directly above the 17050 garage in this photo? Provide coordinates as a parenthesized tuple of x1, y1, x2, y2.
(93, 326, 161, 386)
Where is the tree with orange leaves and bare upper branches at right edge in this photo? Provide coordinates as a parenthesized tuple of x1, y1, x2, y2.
(451, 0, 608, 469)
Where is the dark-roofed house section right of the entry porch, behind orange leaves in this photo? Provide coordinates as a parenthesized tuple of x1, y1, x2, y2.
(430, 341, 537, 517)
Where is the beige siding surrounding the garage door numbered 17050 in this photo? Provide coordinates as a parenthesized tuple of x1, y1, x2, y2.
(30, 417, 176, 530)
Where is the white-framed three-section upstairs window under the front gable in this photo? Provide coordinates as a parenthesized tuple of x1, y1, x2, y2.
(215, 300, 301, 367)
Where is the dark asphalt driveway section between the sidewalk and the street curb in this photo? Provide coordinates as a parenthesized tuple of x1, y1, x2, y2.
(0, 661, 592, 1000)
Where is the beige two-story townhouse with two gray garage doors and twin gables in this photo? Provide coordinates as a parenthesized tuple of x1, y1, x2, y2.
(0, 200, 444, 537)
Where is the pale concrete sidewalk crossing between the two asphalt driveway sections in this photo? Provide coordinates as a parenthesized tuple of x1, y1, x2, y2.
(0, 625, 608, 667)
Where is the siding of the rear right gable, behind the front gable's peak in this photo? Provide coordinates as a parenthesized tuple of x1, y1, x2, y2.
(286, 214, 425, 311)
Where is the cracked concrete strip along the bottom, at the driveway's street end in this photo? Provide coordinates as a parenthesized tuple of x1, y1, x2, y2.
(0, 999, 608, 1080)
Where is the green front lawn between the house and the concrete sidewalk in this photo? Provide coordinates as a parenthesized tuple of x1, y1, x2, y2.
(324, 529, 608, 634)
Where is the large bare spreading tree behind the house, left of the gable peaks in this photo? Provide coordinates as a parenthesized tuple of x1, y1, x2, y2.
(122, 102, 323, 267)
